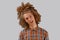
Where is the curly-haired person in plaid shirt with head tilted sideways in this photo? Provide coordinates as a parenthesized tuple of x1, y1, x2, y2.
(17, 3, 49, 40)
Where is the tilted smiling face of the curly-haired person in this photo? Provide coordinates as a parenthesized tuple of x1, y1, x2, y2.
(23, 12, 35, 25)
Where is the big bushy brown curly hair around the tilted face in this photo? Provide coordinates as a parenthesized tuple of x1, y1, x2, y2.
(17, 2, 41, 28)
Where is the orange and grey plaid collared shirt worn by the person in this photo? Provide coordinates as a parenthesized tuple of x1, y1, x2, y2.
(19, 27, 49, 40)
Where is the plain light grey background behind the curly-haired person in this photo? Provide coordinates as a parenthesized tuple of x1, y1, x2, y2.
(0, 0, 60, 40)
